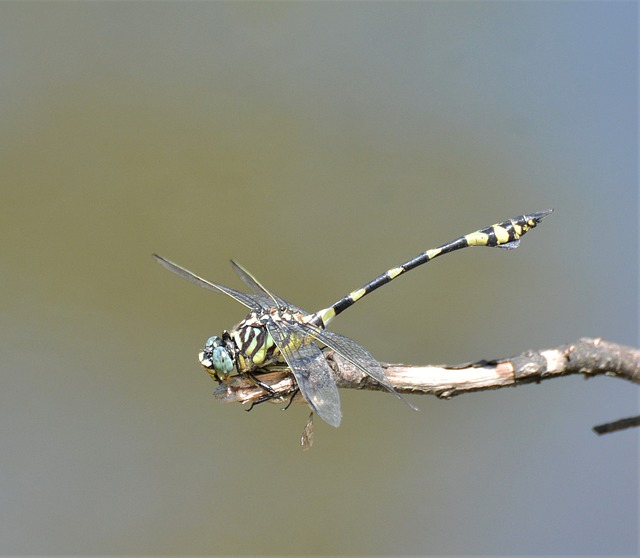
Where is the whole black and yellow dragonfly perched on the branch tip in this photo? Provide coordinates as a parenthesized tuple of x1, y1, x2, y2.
(153, 209, 553, 449)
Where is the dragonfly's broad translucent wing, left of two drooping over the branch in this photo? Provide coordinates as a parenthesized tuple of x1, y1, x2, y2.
(267, 320, 342, 427)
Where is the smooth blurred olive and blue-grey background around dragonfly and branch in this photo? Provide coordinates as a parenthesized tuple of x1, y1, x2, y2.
(0, 2, 638, 555)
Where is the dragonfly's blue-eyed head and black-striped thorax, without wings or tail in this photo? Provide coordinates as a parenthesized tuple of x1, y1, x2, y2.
(200, 308, 313, 381)
